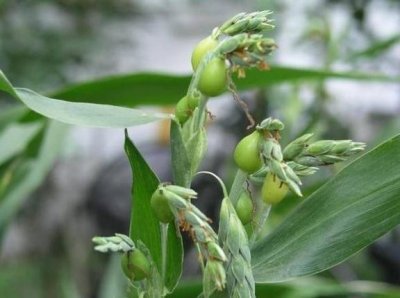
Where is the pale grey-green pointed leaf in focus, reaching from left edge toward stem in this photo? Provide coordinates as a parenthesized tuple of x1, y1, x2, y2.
(0, 71, 170, 128)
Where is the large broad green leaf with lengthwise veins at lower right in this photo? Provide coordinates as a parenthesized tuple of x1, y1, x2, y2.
(252, 135, 400, 283)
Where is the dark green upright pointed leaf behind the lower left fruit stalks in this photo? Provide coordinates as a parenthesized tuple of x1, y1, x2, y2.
(125, 131, 183, 291)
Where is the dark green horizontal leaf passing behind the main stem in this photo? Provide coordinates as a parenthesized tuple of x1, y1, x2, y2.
(45, 66, 400, 107)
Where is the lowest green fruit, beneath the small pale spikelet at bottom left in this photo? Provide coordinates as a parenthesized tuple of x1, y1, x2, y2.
(121, 249, 150, 281)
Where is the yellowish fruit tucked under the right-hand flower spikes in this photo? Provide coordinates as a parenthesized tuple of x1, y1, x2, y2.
(261, 172, 289, 204)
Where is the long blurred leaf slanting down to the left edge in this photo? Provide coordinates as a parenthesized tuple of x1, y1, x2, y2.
(0, 121, 67, 240)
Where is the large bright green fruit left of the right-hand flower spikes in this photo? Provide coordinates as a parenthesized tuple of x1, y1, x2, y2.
(233, 130, 262, 174)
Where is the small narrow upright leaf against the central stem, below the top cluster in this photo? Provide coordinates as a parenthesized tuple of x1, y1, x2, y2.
(170, 121, 192, 187)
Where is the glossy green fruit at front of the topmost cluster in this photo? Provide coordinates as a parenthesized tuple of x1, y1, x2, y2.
(197, 58, 227, 97)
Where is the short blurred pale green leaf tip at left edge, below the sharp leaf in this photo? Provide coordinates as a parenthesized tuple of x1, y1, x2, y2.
(0, 122, 43, 165)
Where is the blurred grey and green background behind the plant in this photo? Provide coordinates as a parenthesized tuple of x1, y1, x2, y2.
(0, 0, 400, 298)
